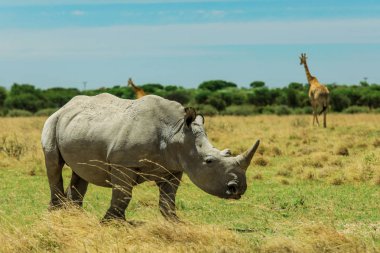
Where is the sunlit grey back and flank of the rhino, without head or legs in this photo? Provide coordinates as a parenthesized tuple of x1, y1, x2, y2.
(46, 94, 184, 181)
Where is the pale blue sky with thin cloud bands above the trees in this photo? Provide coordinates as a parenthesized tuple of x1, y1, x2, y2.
(0, 0, 380, 89)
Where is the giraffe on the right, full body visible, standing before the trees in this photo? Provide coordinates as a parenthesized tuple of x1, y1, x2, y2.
(300, 54, 329, 128)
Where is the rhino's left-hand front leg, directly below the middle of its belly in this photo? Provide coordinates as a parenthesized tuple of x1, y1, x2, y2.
(103, 168, 137, 221)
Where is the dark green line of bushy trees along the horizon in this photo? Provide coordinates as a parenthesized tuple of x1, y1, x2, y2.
(0, 80, 380, 116)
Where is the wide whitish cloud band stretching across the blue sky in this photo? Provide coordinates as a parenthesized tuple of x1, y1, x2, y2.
(0, 19, 380, 60)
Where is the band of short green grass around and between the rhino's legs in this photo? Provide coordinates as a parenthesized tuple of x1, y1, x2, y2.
(0, 165, 380, 246)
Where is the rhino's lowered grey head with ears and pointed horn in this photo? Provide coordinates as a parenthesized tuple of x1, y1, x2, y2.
(177, 108, 260, 199)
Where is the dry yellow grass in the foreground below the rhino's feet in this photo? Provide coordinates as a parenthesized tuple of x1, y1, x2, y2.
(0, 207, 250, 252)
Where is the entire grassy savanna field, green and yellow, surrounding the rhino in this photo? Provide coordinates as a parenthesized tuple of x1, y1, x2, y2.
(0, 114, 380, 252)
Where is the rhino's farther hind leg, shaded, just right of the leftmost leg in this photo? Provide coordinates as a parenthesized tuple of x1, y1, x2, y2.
(65, 171, 88, 207)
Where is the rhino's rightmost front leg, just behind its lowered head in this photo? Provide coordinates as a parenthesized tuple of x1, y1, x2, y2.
(156, 172, 183, 221)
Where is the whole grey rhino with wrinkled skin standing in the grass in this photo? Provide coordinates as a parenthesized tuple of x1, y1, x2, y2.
(41, 94, 259, 219)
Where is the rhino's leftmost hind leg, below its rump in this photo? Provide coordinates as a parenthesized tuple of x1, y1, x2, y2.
(45, 149, 65, 209)
